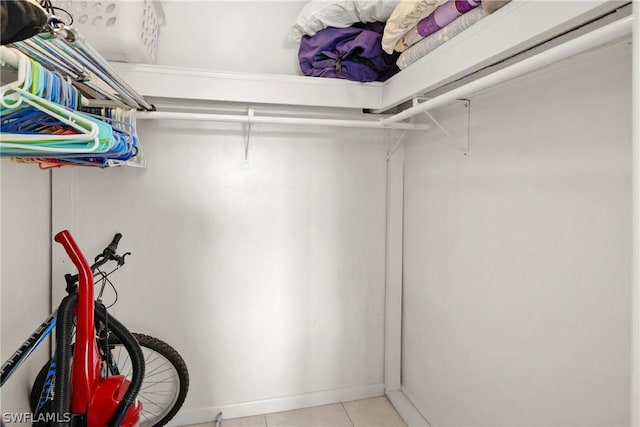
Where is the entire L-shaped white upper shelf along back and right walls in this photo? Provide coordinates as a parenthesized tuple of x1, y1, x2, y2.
(113, 0, 628, 111)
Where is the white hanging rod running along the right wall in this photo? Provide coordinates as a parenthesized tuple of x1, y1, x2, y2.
(381, 16, 633, 125)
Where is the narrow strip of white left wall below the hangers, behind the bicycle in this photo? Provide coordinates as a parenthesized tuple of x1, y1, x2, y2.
(0, 161, 51, 422)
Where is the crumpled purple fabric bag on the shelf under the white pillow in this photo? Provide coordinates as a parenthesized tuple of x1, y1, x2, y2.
(298, 22, 400, 82)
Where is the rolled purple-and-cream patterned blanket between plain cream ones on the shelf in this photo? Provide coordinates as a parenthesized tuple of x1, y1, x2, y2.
(395, 0, 480, 52)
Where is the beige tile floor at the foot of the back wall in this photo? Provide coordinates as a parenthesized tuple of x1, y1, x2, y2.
(189, 396, 407, 427)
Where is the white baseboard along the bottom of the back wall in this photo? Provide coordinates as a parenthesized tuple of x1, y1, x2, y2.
(168, 383, 384, 426)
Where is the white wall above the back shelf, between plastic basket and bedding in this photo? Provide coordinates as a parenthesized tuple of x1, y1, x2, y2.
(156, 0, 306, 75)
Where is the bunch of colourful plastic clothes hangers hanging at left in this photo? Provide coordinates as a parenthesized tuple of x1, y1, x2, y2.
(0, 47, 139, 168)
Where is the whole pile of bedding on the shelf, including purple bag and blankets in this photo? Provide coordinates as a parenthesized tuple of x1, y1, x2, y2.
(289, 0, 510, 82)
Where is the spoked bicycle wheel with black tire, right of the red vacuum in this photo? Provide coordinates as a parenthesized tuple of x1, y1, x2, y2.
(109, 332, 189, 427)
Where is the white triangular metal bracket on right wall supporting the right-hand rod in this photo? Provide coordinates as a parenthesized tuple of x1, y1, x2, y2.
(413, 97, 471, 156)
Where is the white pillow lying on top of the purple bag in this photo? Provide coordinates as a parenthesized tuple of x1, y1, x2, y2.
(289, 0, 400, 41)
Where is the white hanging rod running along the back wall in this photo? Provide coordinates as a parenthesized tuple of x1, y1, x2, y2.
(136, 111, 429, 130)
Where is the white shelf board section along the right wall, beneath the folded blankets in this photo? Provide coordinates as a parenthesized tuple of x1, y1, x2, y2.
(380, 0, 629, 110)
